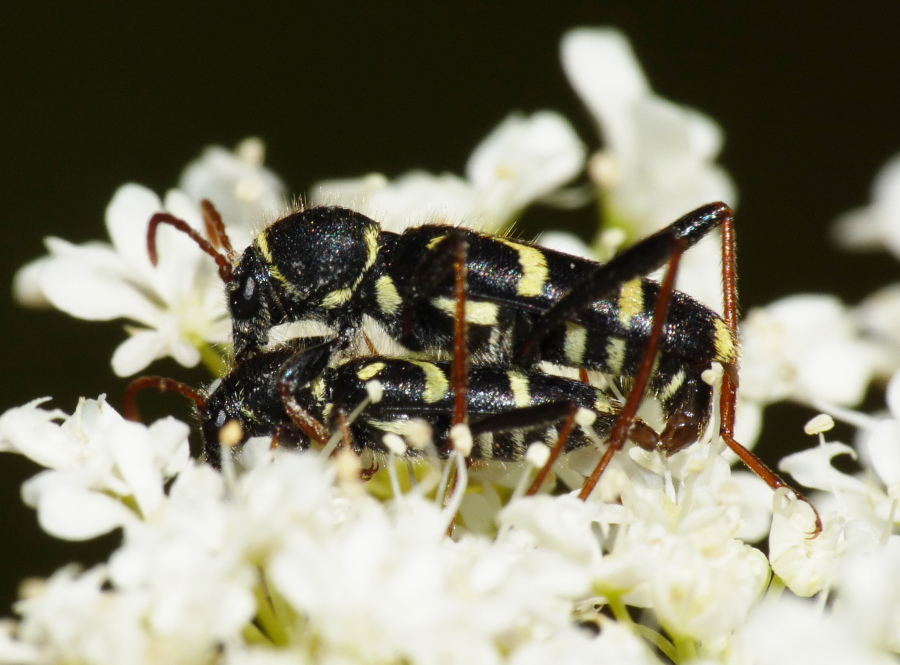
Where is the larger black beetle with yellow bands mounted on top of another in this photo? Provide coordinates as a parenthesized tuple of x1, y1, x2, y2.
(148, 203, 824, 532)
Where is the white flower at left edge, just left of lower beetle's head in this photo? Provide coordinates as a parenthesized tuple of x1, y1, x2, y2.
(0, 400, 188, 540)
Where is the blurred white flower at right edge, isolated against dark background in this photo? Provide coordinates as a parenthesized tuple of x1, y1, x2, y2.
(834, 156, 900, 258)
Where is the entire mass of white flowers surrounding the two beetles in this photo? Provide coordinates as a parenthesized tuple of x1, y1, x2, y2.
(0, 24, 900, 665)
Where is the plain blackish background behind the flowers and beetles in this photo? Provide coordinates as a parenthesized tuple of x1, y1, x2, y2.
(0, 1, 900, 616)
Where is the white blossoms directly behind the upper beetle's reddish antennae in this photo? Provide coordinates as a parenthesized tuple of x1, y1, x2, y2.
(14, 141, 280, 376)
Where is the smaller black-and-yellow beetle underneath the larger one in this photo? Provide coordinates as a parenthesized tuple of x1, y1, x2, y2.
(199, 343, 628, 465)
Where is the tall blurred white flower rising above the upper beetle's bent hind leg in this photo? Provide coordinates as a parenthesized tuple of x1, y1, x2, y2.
(562, 28, 736, 236)
